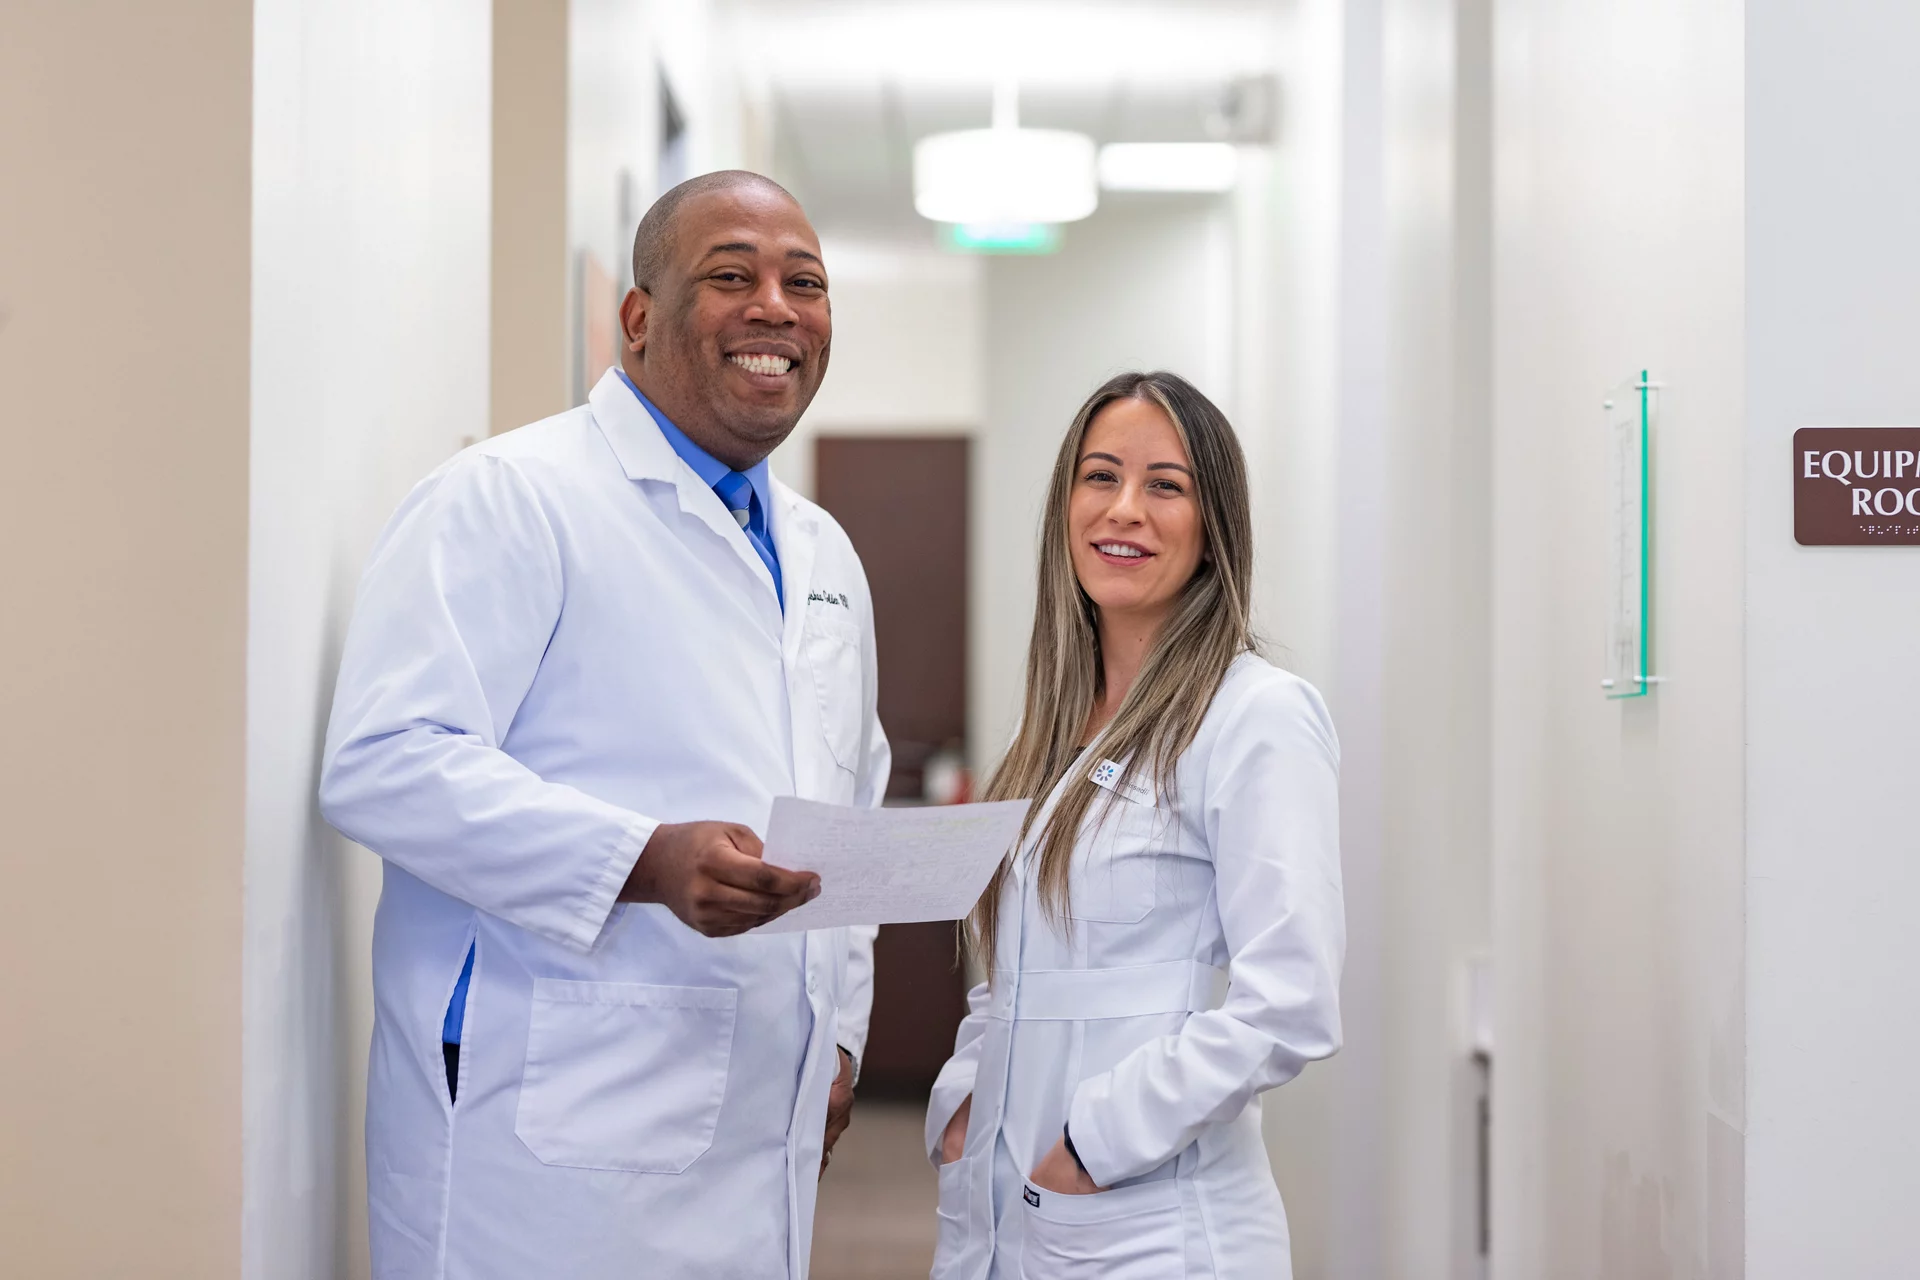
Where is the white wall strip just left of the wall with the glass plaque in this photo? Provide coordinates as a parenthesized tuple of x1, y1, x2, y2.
(1382, 0, 1494, 1280)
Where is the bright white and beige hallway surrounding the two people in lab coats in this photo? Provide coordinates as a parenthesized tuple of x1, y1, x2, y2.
(11, 0, 1920, 1280)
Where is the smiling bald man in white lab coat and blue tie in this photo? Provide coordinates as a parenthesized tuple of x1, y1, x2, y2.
(321, 173, 889, 1280)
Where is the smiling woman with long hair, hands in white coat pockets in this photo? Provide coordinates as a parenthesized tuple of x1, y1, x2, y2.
(927, 372, 1346, 1280)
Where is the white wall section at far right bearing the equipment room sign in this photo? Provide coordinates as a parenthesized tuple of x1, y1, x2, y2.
(1745, 0, 1920, 1280)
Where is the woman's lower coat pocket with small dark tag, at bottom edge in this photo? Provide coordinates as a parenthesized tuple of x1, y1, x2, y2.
(1020, 1178, 1187, 1280)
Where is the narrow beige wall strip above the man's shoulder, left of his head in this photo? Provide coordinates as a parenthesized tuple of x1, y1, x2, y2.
(488, 0, 572, 434)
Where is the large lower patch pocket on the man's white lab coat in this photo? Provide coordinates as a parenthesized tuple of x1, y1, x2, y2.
(513, 979, 739, 1173)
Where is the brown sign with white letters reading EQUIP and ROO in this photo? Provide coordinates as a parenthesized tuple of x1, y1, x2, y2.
(1793, 426, 1920, 547)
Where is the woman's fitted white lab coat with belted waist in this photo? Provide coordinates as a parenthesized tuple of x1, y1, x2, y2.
(927, 656, 1346, 1280)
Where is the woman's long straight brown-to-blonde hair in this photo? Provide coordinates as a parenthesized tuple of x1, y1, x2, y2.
(966, 372, 1254, 979)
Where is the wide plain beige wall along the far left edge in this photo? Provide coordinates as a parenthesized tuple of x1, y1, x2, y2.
(0, 0, 252, 1280)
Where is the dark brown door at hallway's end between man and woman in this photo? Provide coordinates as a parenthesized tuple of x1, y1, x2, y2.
(814, 436, 970, 1096)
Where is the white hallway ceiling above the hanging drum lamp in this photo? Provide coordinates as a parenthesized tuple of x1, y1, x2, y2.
(732, 0, 1277, 236)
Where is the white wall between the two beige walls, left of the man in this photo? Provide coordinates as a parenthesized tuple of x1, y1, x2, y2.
(242, 0, 492, 1280)
